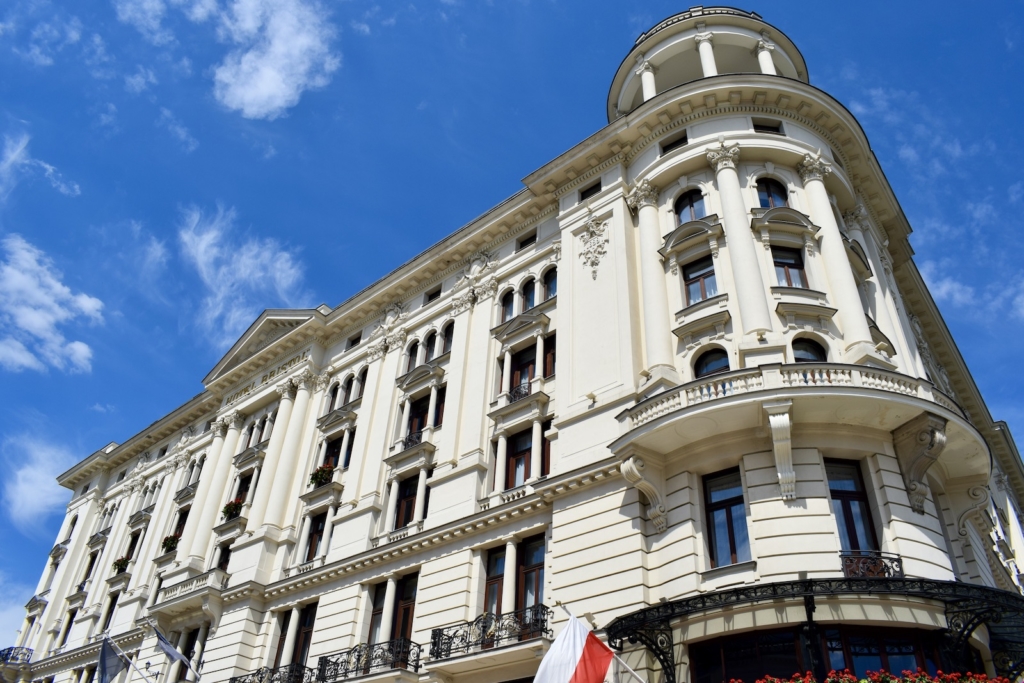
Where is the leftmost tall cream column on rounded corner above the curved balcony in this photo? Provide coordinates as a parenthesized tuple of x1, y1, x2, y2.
(627, 178, 676, 375)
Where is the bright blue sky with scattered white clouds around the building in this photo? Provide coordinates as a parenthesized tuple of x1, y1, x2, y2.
(0, 0, 1024, 646)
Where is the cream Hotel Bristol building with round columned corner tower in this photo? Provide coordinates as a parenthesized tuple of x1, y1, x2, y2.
(6, 7, 1024, 683)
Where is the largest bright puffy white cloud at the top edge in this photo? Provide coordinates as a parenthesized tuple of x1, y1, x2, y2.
(214, 0, 340, 120)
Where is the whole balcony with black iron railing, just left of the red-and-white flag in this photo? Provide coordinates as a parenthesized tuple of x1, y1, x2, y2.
(426, 605, 552, 676)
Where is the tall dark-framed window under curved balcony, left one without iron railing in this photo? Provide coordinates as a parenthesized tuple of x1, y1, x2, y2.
(703, 469, 751, 567)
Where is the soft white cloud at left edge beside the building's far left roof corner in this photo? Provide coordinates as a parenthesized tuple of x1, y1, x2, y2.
(3, 434, 77, 536)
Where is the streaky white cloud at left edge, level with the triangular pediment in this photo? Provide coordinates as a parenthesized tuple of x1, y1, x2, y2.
(0, 234, 103, 372)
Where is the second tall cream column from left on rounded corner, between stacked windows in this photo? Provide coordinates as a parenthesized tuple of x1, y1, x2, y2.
(708, 139, 771, 337)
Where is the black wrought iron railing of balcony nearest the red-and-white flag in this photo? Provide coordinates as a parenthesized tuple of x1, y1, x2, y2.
(430, 605, 551, 659)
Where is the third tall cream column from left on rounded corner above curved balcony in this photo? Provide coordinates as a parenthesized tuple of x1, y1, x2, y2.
(797, 152, 872, 351)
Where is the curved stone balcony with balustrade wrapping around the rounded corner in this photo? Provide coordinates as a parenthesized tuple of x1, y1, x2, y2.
(610, 362, 988, 477)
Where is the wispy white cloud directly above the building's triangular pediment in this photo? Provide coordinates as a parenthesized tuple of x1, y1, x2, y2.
(178, 207, 307, 347)
